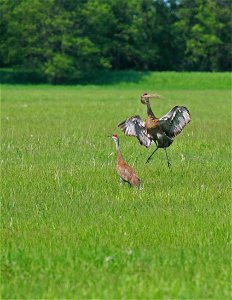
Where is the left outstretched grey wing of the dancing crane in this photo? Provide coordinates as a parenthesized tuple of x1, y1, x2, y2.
(118, 116, 153, 148)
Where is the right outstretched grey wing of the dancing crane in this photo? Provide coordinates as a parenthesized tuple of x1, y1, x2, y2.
(159, 106, 191, 137)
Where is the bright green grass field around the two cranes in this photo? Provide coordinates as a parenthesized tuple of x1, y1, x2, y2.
(1, 73, 231, 299)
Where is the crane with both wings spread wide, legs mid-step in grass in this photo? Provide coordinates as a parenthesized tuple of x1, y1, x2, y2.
(118, 93, 191, 167)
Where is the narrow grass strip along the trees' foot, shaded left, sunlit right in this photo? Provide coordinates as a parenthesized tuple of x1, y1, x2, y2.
(0, 69, 231, 90)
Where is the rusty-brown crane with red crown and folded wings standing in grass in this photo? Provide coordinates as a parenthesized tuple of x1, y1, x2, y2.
(112, 134, 141, 188)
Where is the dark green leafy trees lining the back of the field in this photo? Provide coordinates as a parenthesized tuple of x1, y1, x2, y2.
(0, 0, 232, 83)
